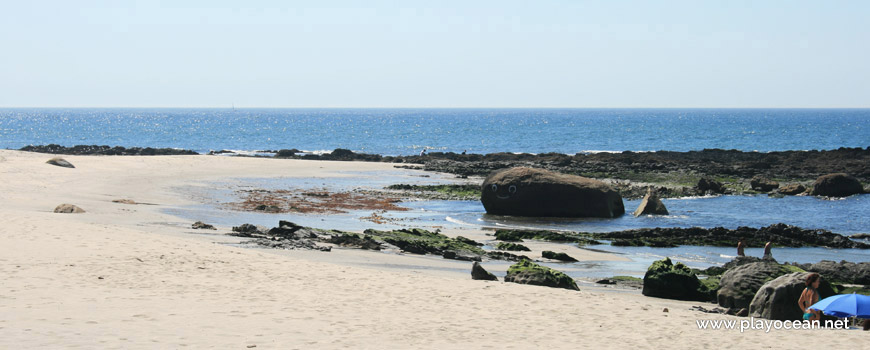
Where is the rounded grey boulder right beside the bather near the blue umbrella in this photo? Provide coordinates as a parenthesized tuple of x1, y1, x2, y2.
(749, 272, 836, 321)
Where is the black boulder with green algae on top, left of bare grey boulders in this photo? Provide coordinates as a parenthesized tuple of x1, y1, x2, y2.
(642, 258, 710, 301)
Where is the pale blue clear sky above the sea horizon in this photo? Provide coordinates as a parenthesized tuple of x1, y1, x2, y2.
(0, 0, 870, 108)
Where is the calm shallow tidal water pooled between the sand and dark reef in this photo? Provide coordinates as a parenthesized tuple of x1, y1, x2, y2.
(165, 174, 870, 277)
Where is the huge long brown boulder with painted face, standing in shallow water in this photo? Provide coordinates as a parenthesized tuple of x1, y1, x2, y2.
(480, 168, 625, 218)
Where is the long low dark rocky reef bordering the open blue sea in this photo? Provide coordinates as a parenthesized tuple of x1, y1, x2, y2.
(21, 144, 870, 199)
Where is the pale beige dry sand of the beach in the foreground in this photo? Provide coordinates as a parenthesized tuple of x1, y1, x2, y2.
(0, 151, 870, 350)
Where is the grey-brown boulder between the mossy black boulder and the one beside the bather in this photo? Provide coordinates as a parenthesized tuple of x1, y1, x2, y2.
(716, 261, 803, 309)
